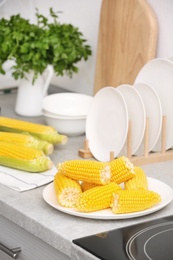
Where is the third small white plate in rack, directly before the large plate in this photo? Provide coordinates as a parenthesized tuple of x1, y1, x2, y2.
(134, 83, 162, 155)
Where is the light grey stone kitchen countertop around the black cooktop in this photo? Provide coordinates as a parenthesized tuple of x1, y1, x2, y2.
(0, 90, 173, 260)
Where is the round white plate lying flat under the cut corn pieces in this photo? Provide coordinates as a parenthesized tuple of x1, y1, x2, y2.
(43, 178, 173, 219)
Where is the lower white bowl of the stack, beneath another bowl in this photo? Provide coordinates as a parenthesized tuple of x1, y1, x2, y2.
(43, 113, 86, 136)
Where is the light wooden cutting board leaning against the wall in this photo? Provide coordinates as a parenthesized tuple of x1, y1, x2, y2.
(94, 0, 158, 94)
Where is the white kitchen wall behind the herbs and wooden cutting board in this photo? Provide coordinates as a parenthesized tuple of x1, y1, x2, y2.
(0, 0, 173, 95)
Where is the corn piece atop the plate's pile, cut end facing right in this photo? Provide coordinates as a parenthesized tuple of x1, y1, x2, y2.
(58, 160, 111, 184)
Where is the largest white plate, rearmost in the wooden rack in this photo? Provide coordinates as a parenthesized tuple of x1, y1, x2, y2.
(135, 58, 173, 151)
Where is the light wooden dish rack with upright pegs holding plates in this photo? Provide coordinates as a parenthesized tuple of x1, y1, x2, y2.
(78, 116, 173, 165)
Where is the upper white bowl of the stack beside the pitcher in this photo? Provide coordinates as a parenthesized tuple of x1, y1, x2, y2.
(42, 93, 93, 116)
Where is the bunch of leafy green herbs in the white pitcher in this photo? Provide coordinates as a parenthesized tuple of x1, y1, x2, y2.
(0, 8, 92, 82)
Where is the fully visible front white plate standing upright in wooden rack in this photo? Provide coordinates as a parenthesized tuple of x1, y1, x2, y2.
(86, 87, 128, 161)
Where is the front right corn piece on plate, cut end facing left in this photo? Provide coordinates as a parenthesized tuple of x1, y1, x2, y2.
(111, 189, 161, 214)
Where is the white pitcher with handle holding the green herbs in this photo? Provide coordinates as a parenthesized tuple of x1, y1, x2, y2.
(15, 66, 53, 116)
